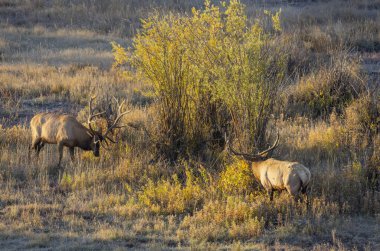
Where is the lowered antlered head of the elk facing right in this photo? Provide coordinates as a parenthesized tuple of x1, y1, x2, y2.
(87, 97, 131, 157)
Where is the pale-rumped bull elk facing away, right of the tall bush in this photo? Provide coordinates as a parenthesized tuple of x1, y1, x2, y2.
(227, 133, 311, 201)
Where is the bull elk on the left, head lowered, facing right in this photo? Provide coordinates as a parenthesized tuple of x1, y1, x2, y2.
(30, 97, 130, 166)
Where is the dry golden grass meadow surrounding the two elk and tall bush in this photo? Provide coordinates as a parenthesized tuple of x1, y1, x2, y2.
(0, 0, 380, 250)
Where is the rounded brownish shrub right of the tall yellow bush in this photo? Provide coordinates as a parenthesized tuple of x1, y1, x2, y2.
(284, 52, 365, 118)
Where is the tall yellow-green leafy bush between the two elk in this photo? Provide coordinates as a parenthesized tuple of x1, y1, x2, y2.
(112, 0, 286, 160)
